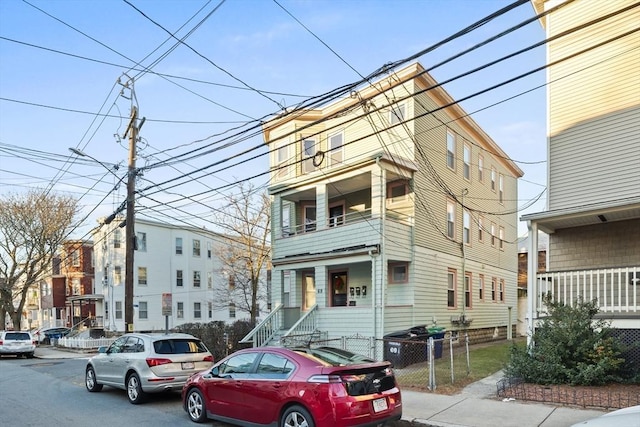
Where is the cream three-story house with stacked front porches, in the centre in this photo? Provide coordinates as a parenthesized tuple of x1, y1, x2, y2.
(245, 64, 522, 346)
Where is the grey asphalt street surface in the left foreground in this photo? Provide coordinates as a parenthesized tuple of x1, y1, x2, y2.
(0, 357, 229, 427)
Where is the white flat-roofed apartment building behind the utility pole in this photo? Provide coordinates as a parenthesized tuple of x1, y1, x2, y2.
(93, 218, 266, 331)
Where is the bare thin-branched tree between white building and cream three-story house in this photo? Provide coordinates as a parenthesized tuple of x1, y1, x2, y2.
(214, 185, 271, 325)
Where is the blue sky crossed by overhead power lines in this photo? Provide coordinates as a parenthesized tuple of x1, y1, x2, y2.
(0, 0, 546, 238)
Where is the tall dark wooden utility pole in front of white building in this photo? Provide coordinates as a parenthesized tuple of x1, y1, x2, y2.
(124, 105, 138, 332)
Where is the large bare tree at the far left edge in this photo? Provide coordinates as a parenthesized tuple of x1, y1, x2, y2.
(0, 190, 78, 329)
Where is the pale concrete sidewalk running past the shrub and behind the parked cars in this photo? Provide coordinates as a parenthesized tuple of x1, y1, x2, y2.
(35, 346, 606, 427)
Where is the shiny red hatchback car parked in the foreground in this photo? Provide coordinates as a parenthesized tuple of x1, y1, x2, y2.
(182, 347, 402, 427)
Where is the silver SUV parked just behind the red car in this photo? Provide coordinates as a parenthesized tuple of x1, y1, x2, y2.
(85, 333, 213, 404)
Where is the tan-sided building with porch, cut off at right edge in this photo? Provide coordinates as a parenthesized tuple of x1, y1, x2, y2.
(522, 0, 640, 340)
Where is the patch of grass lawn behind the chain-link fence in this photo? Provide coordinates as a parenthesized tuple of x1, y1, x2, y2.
(396, 339, 525, 394)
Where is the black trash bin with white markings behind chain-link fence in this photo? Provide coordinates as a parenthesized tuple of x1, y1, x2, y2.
(384, 326, 429, 368)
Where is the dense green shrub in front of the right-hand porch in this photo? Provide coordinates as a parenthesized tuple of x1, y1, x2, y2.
(505, 295, 624, 385)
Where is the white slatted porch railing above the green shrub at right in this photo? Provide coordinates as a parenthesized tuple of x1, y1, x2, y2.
(536, 266, 640, 315)
